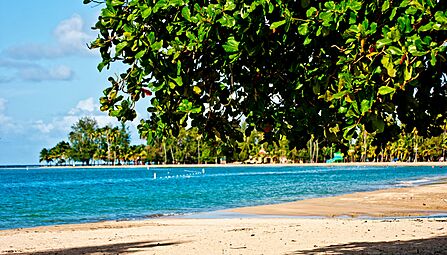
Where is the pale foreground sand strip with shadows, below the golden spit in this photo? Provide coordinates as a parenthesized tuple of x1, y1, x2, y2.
(0, 218, 447, 255)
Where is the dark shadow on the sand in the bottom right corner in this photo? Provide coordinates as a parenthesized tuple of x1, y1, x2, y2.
(289, 236, 447, 255)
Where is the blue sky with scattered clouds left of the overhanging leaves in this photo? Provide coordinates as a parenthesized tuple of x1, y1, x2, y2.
(0, 0, 144, 165)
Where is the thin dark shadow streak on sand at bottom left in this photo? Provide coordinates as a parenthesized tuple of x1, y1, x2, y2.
(8, 241, 184, 255)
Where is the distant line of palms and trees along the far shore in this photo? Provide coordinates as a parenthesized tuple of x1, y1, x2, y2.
(40, 117, 447, 165)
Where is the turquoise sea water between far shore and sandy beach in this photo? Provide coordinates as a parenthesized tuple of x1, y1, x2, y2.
(0, 166, 447, 229)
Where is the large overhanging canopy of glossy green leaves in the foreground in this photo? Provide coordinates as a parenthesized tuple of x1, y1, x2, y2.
(84, 0, 447, 146)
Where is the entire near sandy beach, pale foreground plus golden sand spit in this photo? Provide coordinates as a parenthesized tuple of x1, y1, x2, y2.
(0, 180, 447, 254)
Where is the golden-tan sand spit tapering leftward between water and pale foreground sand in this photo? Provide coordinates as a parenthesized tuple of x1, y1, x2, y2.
(229, 183, 447, 217)
